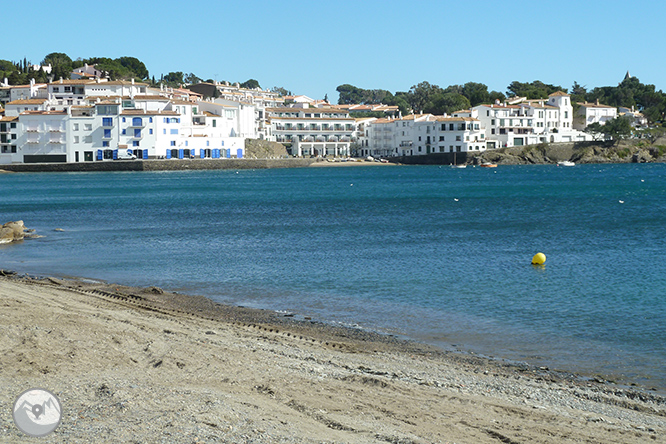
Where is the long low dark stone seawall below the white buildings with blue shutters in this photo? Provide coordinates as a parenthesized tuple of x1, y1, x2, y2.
(1, 158, 318, 172)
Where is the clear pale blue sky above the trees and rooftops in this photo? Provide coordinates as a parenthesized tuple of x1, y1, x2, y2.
(5, 0, 666, 100)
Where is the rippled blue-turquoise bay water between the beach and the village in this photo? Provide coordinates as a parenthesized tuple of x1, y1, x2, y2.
(0, 164, 666, 389)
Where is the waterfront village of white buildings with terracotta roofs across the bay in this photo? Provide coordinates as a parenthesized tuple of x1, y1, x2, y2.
(0, 65, 645, 165)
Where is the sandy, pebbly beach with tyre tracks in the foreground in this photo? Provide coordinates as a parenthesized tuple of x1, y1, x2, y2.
(0, 273, 666, 444)
